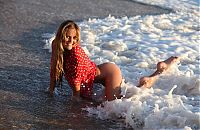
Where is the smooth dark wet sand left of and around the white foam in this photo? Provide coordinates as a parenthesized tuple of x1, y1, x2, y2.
(0, 0, 170, 130)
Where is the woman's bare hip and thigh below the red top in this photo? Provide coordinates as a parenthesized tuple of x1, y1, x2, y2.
(94, 63, 122, 101)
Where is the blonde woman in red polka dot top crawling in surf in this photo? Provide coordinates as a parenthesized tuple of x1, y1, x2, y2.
(49, 20, 178, 101)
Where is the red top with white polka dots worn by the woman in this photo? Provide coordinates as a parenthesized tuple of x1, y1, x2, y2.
(63, 44, 96, 98)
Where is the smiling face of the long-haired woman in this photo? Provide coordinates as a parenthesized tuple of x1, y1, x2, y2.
(62, 28, 78, 50)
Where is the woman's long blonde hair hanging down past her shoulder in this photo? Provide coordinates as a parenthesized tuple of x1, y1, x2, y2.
(52, 20, 80, 85)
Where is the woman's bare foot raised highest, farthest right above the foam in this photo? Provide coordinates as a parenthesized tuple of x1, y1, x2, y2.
(157, 56, 179, 73)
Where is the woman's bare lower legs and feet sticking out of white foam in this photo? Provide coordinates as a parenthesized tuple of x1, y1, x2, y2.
(138, 57, 179, 88)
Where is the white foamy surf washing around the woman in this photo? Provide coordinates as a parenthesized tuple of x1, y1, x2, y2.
(43, 0, 200, 130)
